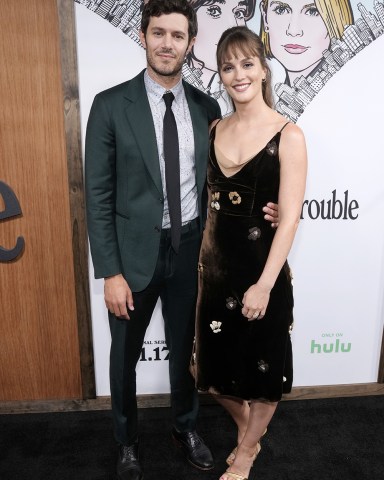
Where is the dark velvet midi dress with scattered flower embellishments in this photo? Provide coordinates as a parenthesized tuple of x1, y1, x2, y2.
(192, 123, 293, 401)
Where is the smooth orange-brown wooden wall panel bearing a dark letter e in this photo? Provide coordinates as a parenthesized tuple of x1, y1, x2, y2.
(0, 0, 82, 401)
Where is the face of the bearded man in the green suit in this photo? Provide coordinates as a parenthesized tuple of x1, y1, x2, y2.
(140, 13, 195, 86)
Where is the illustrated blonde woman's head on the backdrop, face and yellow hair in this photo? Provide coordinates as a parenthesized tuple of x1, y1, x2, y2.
(260, 0, 353, 86)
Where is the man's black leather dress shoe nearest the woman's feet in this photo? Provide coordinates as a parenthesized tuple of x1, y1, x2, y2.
(172, 428, 214, 470)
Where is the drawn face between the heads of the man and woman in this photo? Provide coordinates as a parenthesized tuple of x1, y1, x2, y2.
(193, 0, 246, 72)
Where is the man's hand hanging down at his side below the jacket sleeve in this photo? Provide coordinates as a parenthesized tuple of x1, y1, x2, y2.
(104, 274, 134, 320)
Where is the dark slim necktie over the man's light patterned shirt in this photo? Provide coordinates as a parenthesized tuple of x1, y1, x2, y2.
(163, 92, 181, 253)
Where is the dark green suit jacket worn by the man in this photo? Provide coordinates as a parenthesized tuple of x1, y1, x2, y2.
(85, 71, 220, 291)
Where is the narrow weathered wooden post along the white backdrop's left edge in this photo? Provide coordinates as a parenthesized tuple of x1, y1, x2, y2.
(56, 0, 96, 399)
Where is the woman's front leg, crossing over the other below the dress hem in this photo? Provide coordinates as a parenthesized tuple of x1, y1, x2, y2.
(220, 401, 277, 480)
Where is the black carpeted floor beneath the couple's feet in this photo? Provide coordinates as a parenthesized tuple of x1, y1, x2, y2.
(0, 396, 384, 480)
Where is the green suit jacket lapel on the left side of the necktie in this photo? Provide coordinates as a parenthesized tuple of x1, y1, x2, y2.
(125, 72, 163, 195)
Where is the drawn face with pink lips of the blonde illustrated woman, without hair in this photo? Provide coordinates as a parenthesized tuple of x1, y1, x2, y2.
(261, 0, 330, 74)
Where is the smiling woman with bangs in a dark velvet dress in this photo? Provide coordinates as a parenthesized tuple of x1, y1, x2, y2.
(194, 27, 307, 480)
